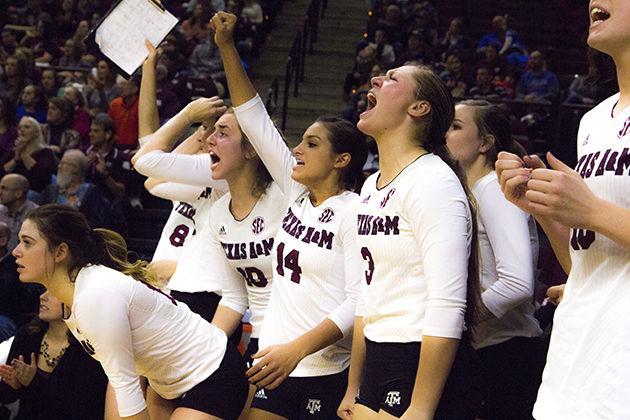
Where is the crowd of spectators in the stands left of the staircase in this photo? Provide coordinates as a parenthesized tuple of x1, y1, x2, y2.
(0, 0, 280, 376)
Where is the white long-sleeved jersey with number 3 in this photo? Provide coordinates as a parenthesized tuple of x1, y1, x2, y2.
(357, 154, 472, 343)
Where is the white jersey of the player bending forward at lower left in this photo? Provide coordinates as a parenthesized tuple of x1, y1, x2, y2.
(66, 265, 227, 417)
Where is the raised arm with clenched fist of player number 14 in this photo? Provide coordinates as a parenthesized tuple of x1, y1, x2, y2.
(211, 12, 300, 195)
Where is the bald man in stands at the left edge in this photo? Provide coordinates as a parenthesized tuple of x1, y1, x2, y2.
(0, 174, 37, 251)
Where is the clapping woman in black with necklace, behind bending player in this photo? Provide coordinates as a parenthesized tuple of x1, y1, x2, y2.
(0, 292, 107, 420)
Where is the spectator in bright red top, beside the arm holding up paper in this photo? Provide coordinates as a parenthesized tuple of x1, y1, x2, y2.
(107, 76, 140, 149)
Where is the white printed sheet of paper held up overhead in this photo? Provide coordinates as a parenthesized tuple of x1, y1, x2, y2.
(94, 0, 177, 75)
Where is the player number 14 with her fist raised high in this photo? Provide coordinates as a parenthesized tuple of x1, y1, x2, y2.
(212, 12, 367, 419)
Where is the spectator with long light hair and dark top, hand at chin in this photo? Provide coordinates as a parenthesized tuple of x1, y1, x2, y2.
(2, 117, 57, 195)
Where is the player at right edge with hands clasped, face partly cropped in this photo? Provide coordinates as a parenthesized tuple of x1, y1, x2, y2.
(496, 0, 630, 420)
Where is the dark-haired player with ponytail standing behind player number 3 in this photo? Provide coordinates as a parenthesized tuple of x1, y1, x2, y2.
(446, 100, 545, 420)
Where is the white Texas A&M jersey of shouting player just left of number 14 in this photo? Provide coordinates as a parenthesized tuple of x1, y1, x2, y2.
(208, 182, 285, 338)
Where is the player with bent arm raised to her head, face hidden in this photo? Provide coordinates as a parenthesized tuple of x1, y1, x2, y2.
(133, 93, 241, 326)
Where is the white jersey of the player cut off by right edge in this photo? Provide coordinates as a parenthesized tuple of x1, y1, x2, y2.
(534, 94, 630, 420)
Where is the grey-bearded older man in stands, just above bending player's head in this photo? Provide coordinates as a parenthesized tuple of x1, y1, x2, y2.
(41, 149, 116, 229)
